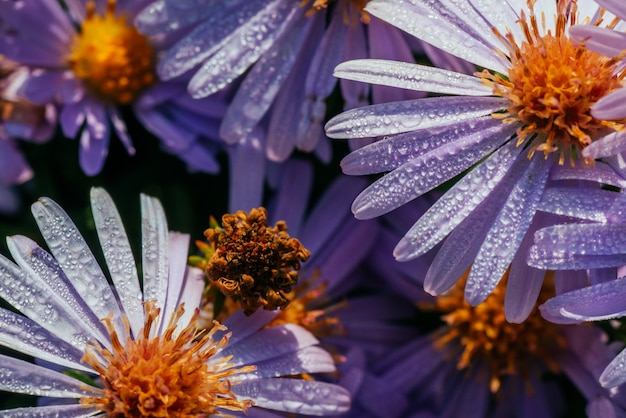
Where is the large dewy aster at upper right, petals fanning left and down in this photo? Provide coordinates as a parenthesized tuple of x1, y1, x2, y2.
(326, 0, 623, 321)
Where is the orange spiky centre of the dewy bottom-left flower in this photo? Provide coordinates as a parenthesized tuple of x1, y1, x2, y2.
(81, 302, 255, 418)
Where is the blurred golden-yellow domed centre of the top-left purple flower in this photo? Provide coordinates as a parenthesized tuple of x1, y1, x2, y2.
(68, 0, 155, 105)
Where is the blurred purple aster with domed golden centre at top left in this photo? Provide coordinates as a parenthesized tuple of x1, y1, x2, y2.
(0, 0, 224, 175)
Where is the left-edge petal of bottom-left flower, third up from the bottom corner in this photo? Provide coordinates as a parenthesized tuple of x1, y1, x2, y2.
(0, 308, 93, 372)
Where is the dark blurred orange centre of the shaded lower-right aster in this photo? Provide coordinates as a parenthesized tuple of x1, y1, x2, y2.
(422, 270, 566, 393)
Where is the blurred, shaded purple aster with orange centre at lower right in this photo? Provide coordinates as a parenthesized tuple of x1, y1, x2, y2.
(368, 222, 626, 418)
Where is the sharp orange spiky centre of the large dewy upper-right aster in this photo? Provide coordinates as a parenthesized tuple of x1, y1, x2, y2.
(479, 1, 625, 165)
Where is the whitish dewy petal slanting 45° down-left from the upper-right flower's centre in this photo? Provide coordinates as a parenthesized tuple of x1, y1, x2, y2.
(393, 142, 525, 261)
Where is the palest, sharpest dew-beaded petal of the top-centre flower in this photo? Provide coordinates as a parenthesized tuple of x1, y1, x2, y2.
(188, 0, 305, 99)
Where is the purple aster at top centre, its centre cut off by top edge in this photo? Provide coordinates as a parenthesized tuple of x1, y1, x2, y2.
(137, 0, 468, 166)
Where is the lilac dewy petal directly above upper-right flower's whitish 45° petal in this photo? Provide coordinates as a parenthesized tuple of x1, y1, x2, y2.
(352, 120, 516, 219)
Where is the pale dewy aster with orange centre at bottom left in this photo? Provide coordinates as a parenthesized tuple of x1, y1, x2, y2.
(0, 189, 349, 417)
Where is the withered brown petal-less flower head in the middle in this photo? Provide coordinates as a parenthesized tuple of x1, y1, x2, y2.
(204, 208, 310, 314)
